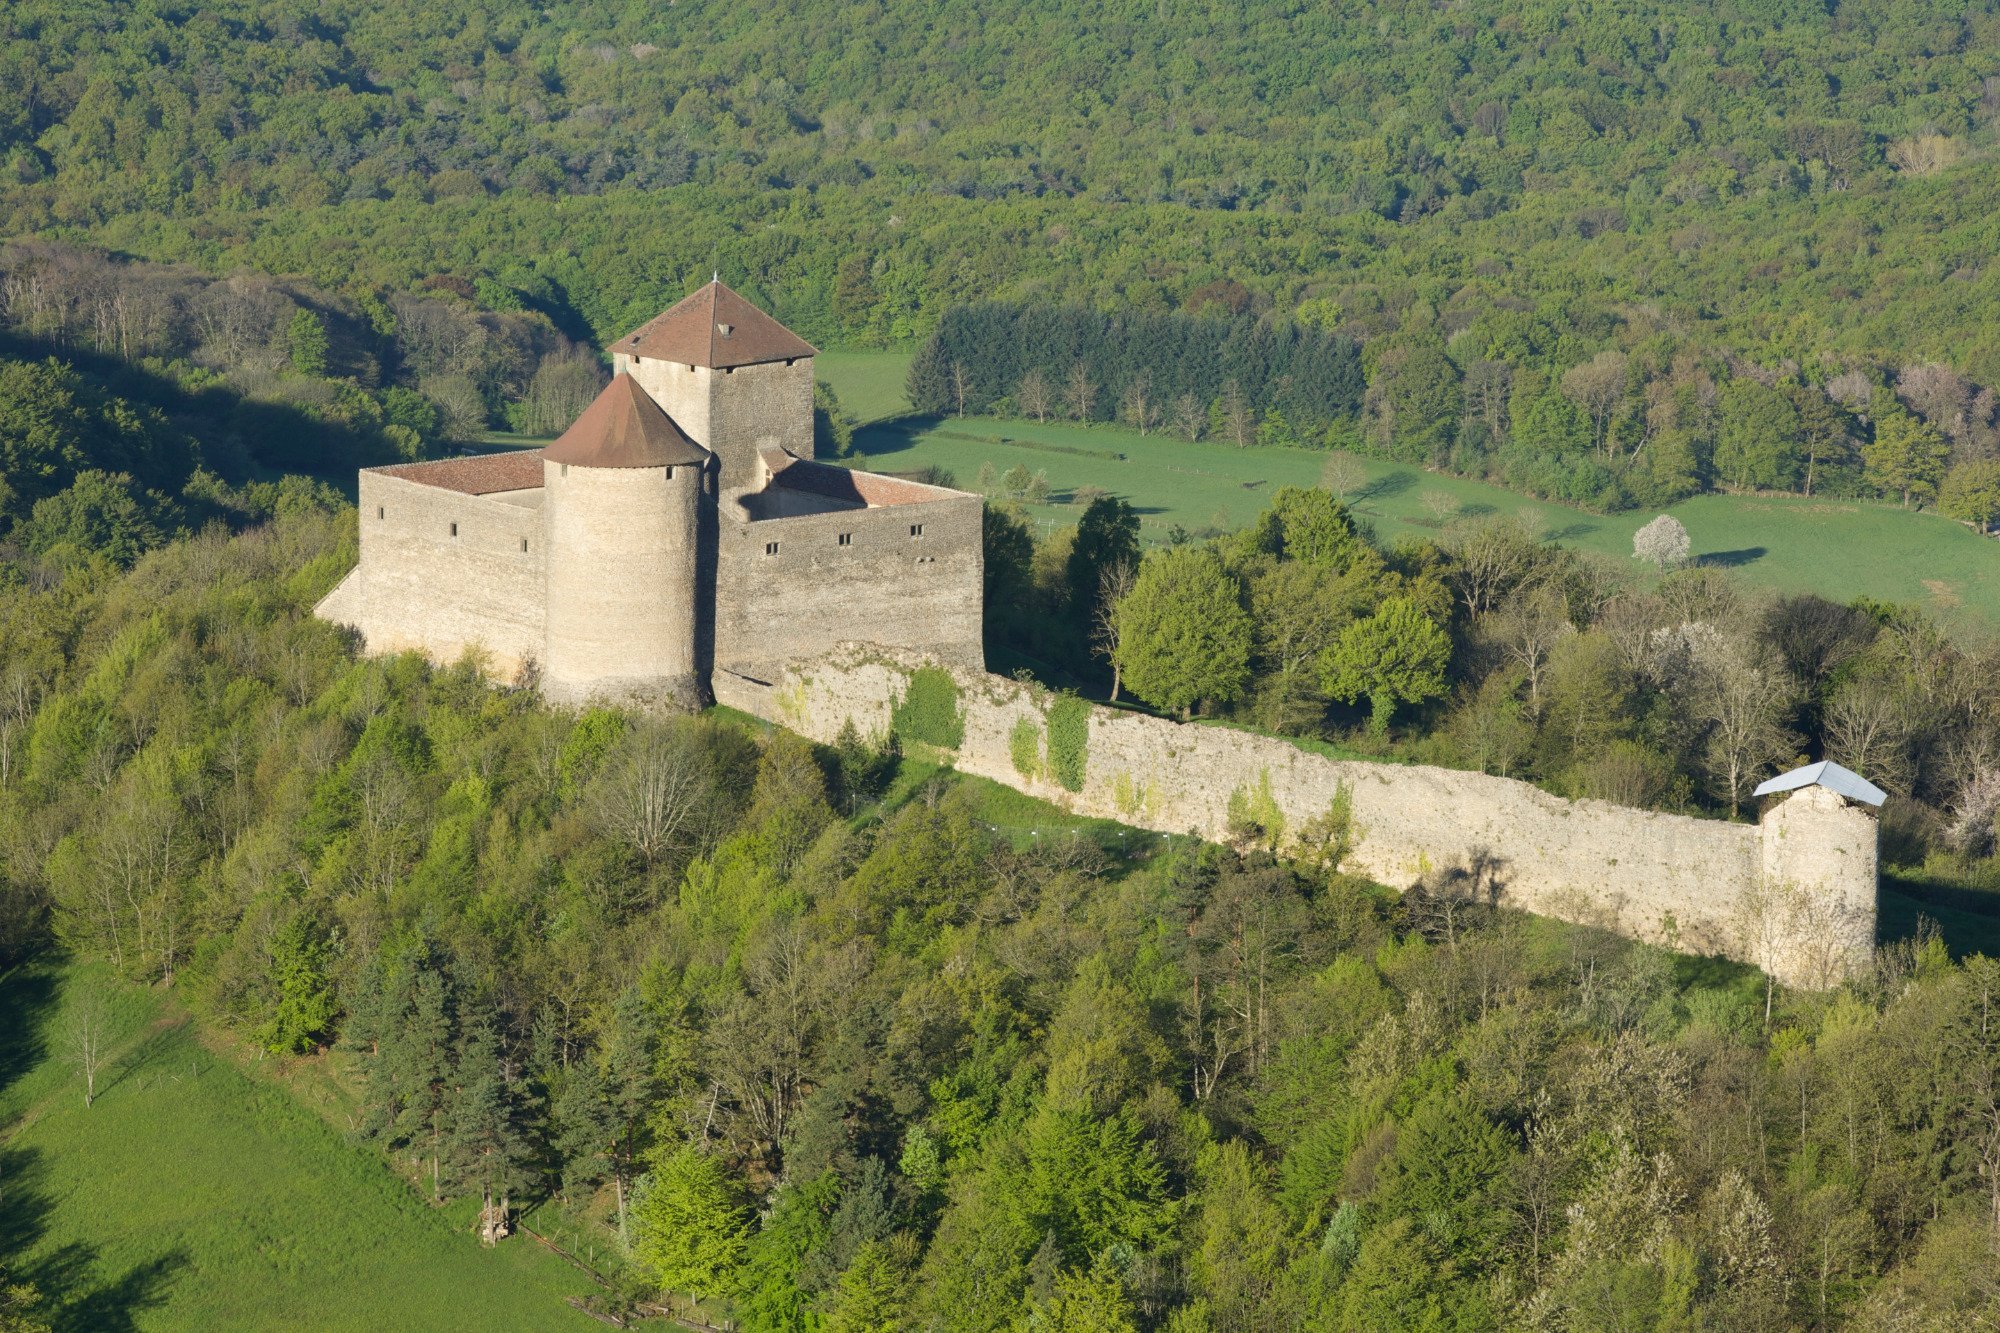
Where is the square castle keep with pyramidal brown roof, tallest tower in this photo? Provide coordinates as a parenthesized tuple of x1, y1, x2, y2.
(610, 278, 818, 494)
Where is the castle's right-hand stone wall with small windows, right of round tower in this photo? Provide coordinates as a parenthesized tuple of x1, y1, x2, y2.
(716, 496, 986, 680)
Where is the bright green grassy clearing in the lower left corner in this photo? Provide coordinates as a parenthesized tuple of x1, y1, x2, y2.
(0, 963, 594, 1329)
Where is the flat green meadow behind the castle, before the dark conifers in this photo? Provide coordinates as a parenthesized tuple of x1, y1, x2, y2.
(820, 352, 2000, 628)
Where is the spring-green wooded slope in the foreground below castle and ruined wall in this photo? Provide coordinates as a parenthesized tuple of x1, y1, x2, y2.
(0, 482, 2000, 1333)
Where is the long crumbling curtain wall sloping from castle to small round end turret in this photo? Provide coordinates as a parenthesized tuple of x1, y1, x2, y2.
(714, 644, 1876, 987)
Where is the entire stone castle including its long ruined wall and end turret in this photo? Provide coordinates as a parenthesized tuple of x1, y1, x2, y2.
(318, 282, 1882, 987)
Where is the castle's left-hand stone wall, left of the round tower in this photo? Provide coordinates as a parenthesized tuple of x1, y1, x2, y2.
(318, 472, 544, 681)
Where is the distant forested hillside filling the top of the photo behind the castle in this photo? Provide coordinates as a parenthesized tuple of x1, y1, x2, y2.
(11, 0, 2000, 370)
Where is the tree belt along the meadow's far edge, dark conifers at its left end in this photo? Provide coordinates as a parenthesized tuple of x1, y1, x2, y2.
(908, 298, 2000, 516)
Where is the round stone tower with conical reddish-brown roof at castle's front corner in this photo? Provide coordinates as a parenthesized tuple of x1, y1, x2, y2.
(542, 374, 714, 709)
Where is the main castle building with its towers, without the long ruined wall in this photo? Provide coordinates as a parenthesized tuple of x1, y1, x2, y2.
(318, 280, 984, 707)
